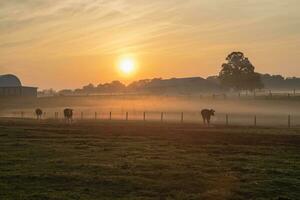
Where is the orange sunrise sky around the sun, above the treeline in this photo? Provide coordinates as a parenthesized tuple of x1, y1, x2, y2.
(0, 0, 300, 89)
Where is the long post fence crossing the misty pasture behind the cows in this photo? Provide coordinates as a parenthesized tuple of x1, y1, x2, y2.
(2, 111, 300, 128)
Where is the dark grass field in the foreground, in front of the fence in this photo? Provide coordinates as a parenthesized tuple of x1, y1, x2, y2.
(0, 119, 300, 200)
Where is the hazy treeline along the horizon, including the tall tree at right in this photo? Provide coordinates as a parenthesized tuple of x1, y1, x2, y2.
(40, 52, 300, 95)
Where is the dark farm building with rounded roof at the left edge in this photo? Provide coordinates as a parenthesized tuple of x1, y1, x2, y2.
(0, 74, 37, 97)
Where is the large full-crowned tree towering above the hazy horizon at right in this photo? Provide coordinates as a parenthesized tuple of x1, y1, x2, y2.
(219, 52, 263, 91)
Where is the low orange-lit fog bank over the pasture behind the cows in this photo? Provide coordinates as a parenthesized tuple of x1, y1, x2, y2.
(0, 96, 300, 126)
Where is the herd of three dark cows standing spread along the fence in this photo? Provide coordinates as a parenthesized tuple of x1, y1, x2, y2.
(35, 108, 215, 124)
